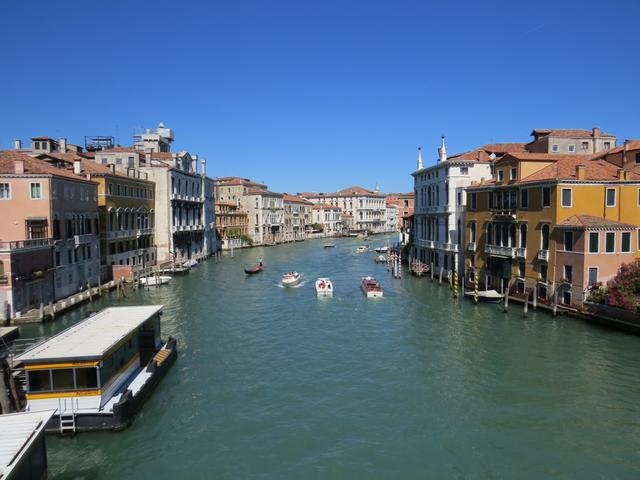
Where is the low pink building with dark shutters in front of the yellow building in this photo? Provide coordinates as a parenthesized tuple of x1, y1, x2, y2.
(555, 215, 640, 306)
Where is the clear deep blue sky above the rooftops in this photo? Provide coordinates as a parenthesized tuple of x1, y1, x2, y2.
(0, 0, 640, 192)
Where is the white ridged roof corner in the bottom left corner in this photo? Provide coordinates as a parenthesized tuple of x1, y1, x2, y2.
(0, 410, 55, 478)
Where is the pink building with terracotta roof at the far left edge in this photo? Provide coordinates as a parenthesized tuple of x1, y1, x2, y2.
(0, 150, 100, 318)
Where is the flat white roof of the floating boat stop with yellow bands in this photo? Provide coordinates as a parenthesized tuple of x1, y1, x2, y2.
(16, 305, 162, 364)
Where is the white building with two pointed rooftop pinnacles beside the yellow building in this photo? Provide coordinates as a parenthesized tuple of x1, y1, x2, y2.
(411, 137, 524, 275)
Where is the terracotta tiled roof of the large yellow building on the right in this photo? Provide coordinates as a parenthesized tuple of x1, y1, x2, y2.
(521, 155, 640, 183)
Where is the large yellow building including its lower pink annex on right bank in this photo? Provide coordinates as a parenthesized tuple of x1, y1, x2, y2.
(465, 152, 640, 305)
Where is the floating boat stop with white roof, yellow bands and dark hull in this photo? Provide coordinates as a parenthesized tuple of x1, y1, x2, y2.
(15, 305, 177, 434)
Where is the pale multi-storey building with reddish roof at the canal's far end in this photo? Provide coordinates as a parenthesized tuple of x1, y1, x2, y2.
(298, 186, 387, 233)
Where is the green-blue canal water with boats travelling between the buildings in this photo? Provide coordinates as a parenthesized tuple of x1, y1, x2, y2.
(22, 237, 640, 479)
